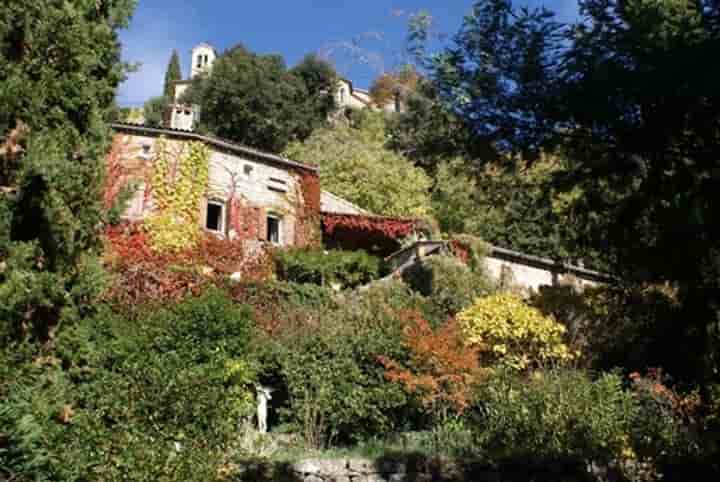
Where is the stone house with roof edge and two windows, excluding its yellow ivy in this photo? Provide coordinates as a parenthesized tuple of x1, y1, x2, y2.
(106, 124, 321, 246)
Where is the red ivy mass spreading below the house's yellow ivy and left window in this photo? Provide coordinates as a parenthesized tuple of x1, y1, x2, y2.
(105, 224, 272, 306)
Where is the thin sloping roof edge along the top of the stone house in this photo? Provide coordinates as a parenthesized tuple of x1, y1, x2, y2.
(110, 122, 318, 173)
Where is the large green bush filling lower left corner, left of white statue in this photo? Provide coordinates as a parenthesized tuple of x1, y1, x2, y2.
(0, 291, 255, 481)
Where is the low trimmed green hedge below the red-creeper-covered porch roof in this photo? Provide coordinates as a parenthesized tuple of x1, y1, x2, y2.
(275, 249, 380, 288)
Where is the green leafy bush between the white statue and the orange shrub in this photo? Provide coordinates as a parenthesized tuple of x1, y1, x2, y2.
(276, 320, 408, 447)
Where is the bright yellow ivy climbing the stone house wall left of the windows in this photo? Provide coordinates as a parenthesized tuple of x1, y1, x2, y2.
(145, 139, 210, 251)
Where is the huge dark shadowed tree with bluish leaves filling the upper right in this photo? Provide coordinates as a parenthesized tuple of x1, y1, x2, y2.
(418, 0, 720, 384)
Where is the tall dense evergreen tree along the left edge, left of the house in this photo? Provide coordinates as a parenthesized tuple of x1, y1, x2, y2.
(0, 0, 135, 341)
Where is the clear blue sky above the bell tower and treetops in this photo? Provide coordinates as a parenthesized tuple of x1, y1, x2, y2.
(118, 0, 576, 106)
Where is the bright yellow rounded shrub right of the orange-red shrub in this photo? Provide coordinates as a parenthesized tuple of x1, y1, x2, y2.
(457, 294, 575, 370)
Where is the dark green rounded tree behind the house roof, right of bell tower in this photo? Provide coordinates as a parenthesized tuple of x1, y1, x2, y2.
(185, 45, 316, 152)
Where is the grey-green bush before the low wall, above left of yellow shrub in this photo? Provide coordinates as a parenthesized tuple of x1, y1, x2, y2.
(403, 256, 493, 319)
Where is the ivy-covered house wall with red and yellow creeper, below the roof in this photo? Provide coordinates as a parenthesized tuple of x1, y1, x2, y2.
(105, 132, 320, 248)
